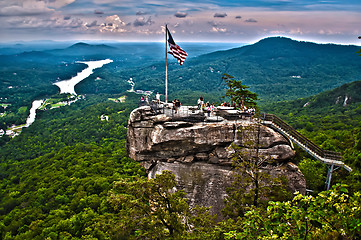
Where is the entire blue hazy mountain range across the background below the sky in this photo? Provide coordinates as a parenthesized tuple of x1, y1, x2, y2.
(0, 37, 361, 108)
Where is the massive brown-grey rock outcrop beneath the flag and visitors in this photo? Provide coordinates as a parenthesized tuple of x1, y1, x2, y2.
(127, 106, 306, 217)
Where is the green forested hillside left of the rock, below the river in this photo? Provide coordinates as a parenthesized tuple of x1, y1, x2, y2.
(0, 95, 145, 239)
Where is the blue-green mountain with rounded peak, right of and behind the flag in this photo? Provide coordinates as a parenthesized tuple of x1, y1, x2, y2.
(120, 37, 361, 102)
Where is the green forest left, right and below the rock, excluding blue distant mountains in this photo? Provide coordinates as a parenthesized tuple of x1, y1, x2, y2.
(0, 87, 361, 239)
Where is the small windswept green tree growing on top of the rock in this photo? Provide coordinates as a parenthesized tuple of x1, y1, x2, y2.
(222, 73, 258, 107)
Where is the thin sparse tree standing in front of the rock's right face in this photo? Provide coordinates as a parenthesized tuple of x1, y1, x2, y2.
(223, 122, 291, 218)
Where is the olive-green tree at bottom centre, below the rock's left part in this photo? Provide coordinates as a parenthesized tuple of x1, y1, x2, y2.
(109, 171, 214, 239)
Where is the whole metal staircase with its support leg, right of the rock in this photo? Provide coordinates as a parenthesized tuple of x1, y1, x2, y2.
(262, 114, 352, 190)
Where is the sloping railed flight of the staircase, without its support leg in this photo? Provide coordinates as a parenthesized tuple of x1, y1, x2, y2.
(263, 113, 352, 171)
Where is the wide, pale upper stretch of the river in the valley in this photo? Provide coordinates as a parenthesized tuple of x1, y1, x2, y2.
(54, 59, 113, 95)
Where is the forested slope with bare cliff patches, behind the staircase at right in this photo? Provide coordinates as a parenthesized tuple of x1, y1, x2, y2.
(262, 81, 361, 191)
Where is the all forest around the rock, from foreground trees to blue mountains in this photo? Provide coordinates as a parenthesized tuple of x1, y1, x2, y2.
(0, 38, 361, 240)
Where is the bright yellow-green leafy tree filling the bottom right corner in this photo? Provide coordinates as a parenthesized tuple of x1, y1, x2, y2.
(225, 185, 361, 239)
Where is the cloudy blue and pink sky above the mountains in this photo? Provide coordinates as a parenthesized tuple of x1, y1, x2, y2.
(0, 0, 361, 45)
